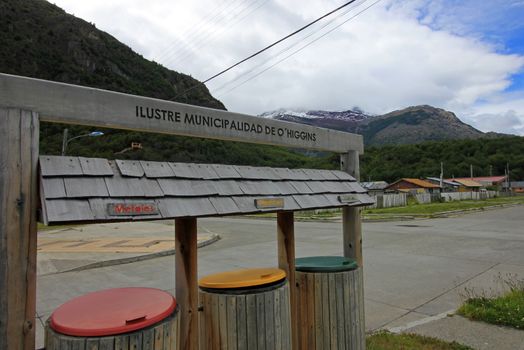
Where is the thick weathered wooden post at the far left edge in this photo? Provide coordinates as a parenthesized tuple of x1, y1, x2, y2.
(0, 108, 39, 350)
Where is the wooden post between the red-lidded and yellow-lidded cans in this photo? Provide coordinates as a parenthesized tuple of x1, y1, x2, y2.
(175, 218, 198, 350)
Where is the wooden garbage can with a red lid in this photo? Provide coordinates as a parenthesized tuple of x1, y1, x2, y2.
(45, 287, 178, 350)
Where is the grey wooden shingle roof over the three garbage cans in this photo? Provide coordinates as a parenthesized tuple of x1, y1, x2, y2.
(40, 156, 373, 224)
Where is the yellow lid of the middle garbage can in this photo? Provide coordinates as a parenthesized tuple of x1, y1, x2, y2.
(198, 268, 286, 289)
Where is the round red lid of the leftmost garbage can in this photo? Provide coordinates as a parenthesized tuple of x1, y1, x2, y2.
(50, 288, 176, 337)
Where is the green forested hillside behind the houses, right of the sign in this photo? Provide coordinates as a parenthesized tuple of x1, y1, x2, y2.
(361, 137, 524, 182)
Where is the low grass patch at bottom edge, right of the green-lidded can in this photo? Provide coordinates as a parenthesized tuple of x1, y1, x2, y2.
(366, 332, 472, 350)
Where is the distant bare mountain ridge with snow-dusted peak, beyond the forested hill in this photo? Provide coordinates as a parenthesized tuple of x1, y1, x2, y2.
(261, 105, 494, 145)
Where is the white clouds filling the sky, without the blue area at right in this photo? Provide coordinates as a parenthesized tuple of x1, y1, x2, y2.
(49, 0, 524, 134)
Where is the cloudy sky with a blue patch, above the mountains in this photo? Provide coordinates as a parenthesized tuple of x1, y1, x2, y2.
(52, 0, 524, 135)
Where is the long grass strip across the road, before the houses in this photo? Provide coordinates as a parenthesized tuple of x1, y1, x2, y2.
(364, 196, 524, 215)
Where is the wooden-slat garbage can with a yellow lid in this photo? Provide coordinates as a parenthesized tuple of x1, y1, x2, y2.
(199, 268, 291, 350)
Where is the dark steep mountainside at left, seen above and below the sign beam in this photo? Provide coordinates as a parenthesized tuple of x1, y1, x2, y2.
(0, 0, 331, 167)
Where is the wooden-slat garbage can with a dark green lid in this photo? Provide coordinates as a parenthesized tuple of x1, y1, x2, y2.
(295, 256, 365, 350)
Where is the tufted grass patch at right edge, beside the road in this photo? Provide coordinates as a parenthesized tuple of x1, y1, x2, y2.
(458, 277, 524, 329)
